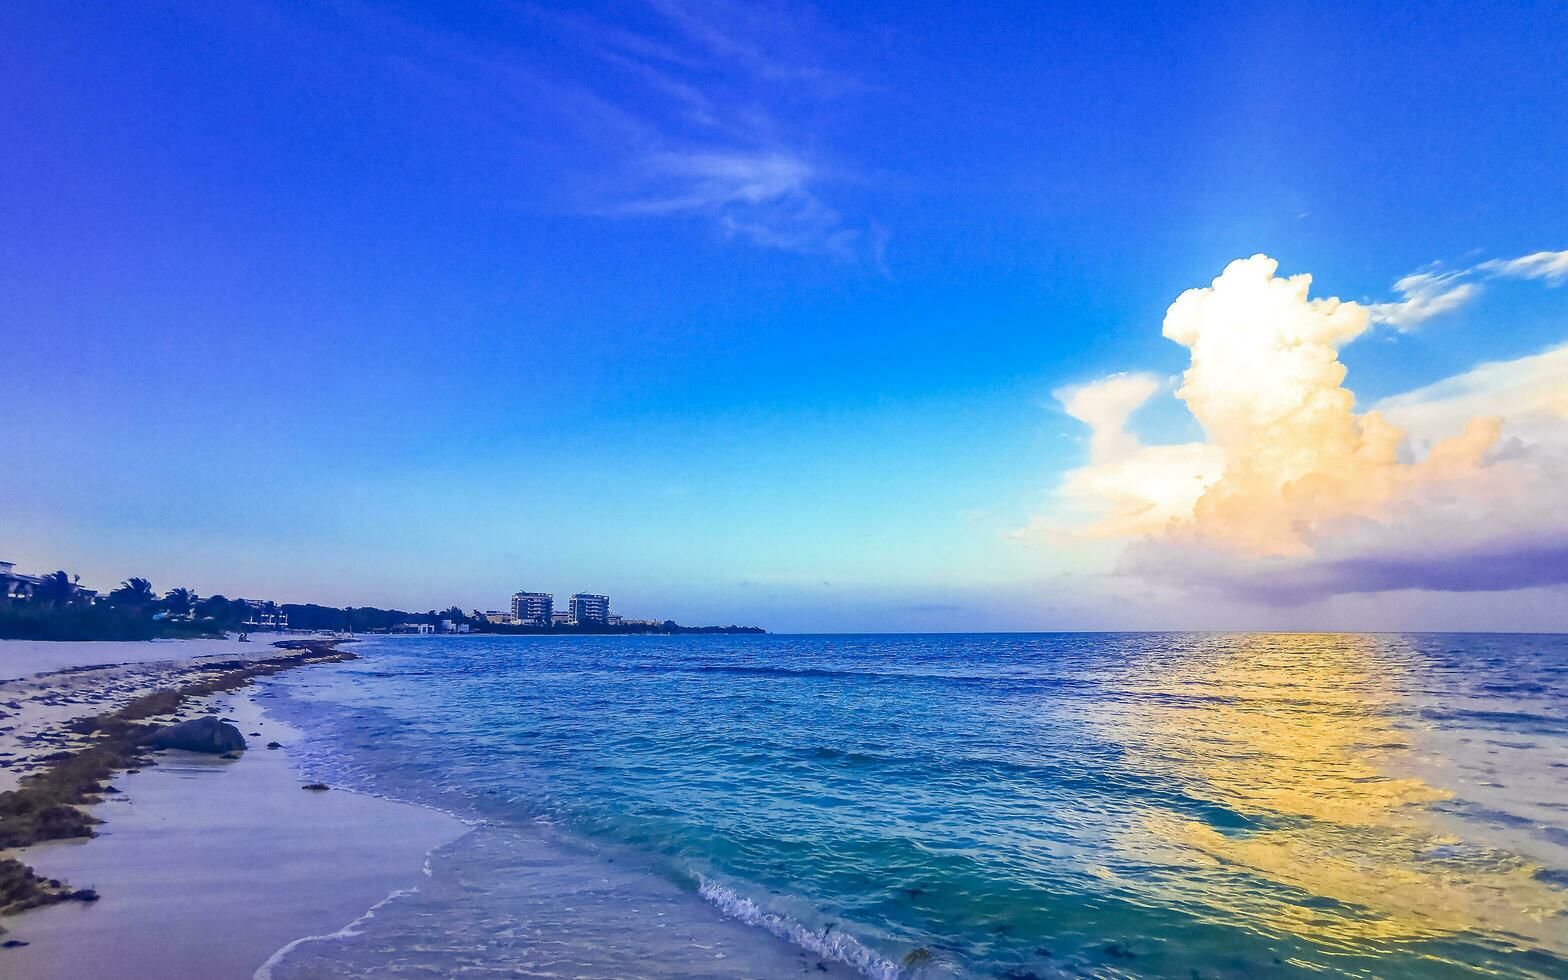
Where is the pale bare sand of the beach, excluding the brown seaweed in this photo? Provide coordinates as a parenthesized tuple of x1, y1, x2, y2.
(0, 641, 466, 978)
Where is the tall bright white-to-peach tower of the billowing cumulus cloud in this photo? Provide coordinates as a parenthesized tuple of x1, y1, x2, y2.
(1163, 256, 1479, 557)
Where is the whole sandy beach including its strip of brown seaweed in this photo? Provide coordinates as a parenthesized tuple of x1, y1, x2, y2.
(0, 640, 467, 978)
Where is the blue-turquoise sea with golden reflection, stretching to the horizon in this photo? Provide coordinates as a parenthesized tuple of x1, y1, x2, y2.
(265, 633, 1568, 980)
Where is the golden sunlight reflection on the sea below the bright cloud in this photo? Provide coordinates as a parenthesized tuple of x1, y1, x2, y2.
(1110, 633, 1568, 953)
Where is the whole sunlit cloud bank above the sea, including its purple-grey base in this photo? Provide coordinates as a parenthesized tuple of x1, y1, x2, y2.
(1022, 256, 1568, 602)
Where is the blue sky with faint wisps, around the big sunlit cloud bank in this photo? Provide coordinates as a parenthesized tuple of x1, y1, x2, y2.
(0, 2, 1568, 629)
